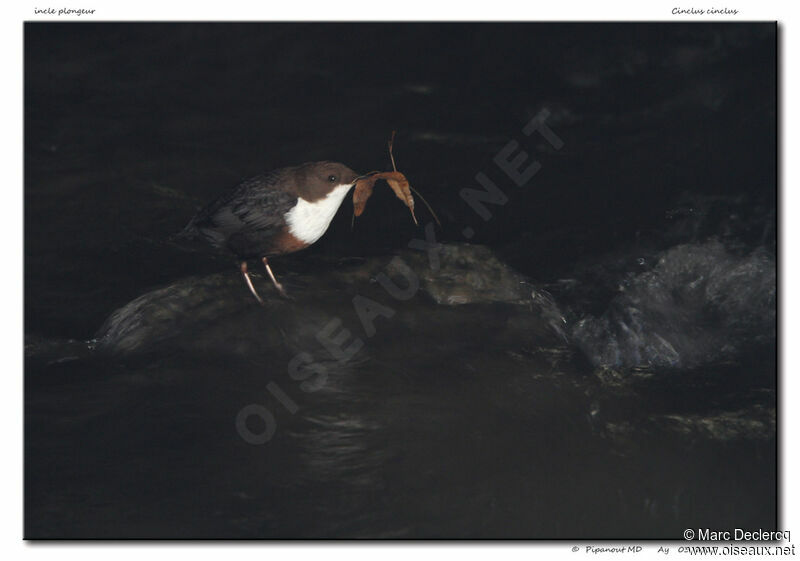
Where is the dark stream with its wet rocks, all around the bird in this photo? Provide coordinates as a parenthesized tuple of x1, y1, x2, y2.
(25, 24, 777, 539)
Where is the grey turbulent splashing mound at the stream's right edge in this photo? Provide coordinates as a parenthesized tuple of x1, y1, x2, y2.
(572, 240, 776, 368)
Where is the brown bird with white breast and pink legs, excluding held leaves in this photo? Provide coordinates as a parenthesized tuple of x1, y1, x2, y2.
(180, 162, 359, 302)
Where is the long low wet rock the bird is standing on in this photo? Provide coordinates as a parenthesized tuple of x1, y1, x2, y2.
(96, 244, 565, 358)
